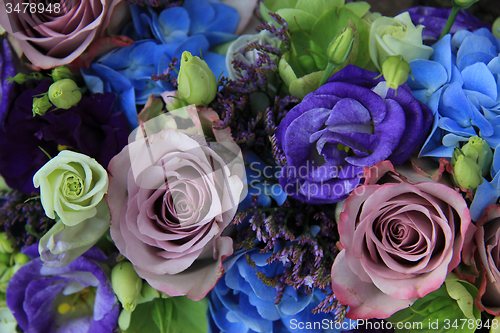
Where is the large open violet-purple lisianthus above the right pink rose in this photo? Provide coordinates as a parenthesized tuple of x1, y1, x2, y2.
(277, 65, 432, 204)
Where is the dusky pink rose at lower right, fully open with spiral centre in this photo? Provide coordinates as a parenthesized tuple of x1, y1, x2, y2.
(332, 161, 471, 319)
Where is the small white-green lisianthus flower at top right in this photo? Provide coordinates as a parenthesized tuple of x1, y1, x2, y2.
(370, 12, 433, 70)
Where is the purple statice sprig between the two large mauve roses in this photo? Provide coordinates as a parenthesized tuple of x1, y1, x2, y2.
(233, 196, 340, 312)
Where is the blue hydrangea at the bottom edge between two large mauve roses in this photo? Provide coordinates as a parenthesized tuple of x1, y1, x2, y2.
(208, 249, 349, 333)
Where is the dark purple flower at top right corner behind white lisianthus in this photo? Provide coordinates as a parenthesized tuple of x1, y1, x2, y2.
(405, 6, 491, 44)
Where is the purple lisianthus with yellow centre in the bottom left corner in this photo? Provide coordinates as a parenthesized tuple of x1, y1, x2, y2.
(6, 244, 119, 333)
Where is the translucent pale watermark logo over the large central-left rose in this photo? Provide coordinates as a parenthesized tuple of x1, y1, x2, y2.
(128, 105, 247, 220)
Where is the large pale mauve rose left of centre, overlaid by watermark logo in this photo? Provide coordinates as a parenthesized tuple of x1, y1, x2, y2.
(107, 108, 245, 300)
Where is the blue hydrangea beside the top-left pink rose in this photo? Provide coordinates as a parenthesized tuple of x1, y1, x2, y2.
(82, 0, 239, 128)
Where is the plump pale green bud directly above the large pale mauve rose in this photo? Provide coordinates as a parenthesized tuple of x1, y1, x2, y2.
(177, 51, 217, 105)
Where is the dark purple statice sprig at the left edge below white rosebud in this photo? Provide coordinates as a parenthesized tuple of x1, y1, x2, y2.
(0, 190, 55, 247)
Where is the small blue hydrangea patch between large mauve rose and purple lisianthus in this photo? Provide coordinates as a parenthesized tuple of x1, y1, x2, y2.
(238, 151, 288, 211)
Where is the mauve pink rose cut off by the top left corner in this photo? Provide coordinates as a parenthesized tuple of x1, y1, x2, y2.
(0, 0, 121, 69)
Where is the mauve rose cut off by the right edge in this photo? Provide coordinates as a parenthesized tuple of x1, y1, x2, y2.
(468, 205, 500, 316)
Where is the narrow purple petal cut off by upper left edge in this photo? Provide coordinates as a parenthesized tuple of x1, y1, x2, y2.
(0, 39, 16, 126)
